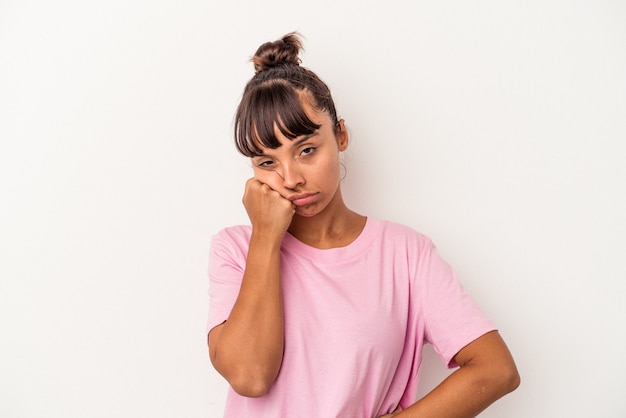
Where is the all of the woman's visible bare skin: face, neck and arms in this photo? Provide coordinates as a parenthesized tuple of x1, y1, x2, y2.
(209, 100, 519, 418)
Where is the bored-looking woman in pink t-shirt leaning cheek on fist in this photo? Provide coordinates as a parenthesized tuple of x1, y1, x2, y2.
(207, 33, 519, 418)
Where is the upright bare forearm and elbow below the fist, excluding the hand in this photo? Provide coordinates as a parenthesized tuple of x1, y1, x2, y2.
(211, 232, 284, 396)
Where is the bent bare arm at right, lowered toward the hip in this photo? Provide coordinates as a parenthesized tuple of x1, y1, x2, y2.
(393, 331, 520, 418)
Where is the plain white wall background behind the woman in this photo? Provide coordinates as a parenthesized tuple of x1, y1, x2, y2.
(0, 0, 626, 418)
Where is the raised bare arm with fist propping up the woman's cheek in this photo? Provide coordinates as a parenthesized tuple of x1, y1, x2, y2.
(208, 179, 294, 397)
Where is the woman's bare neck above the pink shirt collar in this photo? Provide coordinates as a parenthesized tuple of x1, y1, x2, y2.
(288, 190, 366, 249)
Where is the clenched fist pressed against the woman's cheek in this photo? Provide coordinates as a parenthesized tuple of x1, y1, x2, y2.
(242, 178, 295, 235)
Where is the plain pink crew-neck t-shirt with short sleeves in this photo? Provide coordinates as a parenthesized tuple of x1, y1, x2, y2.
(207, 218, 495, 418)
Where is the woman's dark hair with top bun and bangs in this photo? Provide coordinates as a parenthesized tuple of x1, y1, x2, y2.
(235, 32, 339, 157)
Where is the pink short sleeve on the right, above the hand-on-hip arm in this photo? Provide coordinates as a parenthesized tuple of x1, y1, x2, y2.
(417, 240, 495, 368)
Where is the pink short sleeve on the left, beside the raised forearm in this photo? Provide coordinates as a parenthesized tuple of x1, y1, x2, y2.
(206, 227, 249, 333)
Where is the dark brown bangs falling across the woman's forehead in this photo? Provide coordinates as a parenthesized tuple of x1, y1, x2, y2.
(235, 82, 321, 157)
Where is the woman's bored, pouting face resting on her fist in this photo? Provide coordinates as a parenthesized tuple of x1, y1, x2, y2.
(252, 103, 348, 217)
